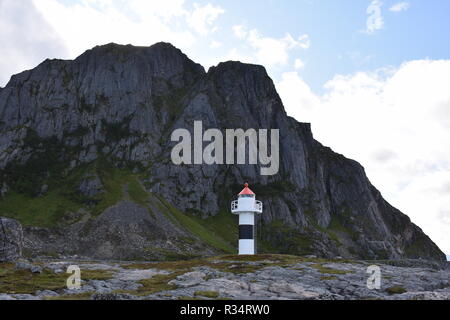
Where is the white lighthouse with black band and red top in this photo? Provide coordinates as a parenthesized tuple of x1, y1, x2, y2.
(231, 183, 262, 255)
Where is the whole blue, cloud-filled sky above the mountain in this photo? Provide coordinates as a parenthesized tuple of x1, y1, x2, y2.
(0, 0, 450, 254)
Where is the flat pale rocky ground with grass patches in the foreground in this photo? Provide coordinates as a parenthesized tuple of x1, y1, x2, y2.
(0, 255, 450, 300)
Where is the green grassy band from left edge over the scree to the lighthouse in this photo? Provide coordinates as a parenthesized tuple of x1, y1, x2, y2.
(0, 162, 237, 253)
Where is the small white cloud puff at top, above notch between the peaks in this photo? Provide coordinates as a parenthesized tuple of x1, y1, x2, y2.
(187, 3, 225, 35)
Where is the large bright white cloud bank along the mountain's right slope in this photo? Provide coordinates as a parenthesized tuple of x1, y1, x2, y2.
(277, 60, 450, 253)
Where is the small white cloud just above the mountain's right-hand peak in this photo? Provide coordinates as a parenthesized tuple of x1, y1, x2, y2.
(233, 25, 311, 68)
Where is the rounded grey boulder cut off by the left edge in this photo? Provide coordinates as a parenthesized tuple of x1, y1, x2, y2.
(0, 217, 23, 262)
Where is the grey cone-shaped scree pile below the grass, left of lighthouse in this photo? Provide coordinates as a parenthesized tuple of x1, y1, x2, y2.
(25, 201, 214, 260)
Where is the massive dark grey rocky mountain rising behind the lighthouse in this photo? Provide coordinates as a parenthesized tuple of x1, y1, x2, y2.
(0, 43, 445, 260)
